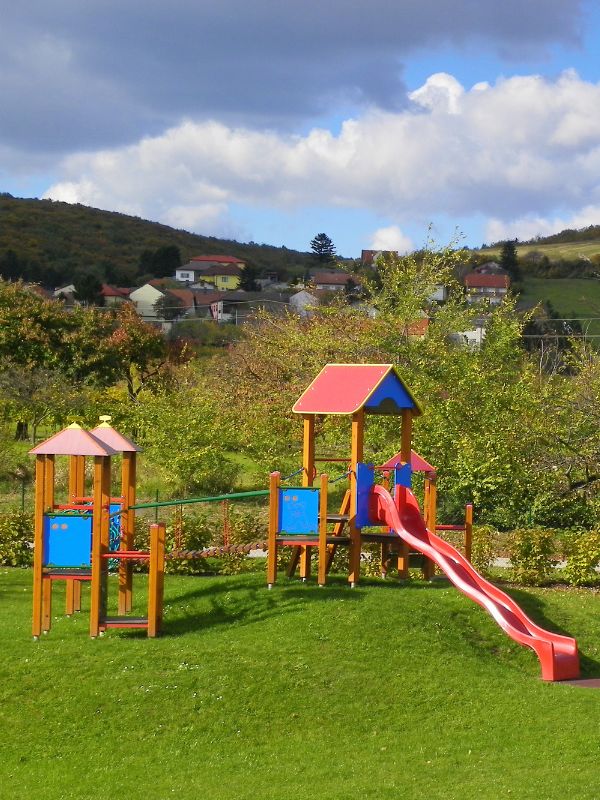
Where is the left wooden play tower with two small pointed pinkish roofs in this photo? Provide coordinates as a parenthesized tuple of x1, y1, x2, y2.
(31, 417, 164, 639)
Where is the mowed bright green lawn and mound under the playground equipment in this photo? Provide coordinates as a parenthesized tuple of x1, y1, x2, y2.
(0, 569, 600, 800)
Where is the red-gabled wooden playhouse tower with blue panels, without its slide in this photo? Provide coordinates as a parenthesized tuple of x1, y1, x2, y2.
(267, 364, 421, 586)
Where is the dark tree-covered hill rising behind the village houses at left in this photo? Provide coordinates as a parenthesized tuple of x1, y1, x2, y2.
(0, 194, 311, 286)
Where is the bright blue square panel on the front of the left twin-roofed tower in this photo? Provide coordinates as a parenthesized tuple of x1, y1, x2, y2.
(43, 514, 92, 567)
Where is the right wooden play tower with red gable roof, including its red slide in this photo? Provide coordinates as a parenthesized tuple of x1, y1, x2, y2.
(267, 364, 579, 681)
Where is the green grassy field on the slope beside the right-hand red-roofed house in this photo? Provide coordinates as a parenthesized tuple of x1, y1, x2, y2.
(520, 278, 600, 336)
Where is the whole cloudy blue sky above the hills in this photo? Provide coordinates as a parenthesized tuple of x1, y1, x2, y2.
(0, 0, 600, 257)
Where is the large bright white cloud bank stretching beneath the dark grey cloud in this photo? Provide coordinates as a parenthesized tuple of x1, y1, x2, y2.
(46, 71, 600, 239)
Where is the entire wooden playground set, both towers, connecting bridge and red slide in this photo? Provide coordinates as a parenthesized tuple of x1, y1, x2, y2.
(31, 364, 579, 681)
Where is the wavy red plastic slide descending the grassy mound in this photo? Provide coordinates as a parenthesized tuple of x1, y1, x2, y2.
(371, 486, 579, 681)
